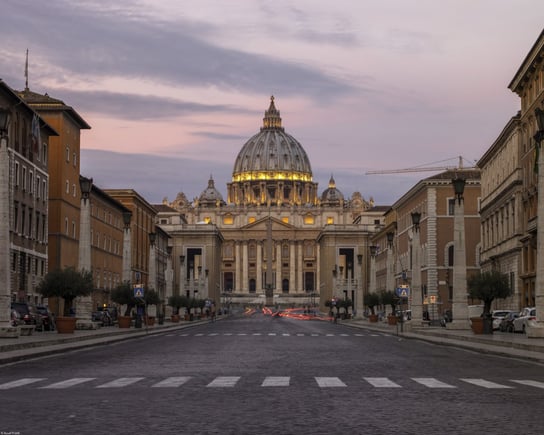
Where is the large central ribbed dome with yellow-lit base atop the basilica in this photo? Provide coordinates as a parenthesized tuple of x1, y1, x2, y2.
(228, 96, 317, 205)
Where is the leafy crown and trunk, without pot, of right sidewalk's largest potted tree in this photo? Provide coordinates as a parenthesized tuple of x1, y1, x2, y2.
(467, 270, 513, 317)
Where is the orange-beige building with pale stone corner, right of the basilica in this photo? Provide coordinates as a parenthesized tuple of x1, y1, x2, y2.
(371, 169, 480, 321)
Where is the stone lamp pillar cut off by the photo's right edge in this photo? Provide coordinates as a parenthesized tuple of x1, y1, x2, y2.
(526, 108, 544, 338)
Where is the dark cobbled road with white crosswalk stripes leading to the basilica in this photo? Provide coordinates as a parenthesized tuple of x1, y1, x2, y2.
(0, 314, 544, 435)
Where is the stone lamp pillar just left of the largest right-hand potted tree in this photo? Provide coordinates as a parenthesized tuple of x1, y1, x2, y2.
(446, 177, 470, 329)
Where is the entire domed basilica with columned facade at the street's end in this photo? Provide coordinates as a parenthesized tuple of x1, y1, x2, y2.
(156, 97, 389, 312)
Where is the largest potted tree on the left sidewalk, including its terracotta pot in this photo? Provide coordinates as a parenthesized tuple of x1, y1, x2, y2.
(36, 267, 93, 334)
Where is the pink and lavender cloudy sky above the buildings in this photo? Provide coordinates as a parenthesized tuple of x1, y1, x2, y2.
(0, 0, 544, 205)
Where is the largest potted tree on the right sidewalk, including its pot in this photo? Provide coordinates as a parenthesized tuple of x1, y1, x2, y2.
(467, 270, 513, 334)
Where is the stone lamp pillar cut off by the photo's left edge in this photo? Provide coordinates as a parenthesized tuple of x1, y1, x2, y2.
(0, 107, 19, 338)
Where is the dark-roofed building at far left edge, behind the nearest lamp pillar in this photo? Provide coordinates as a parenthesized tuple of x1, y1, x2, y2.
(0, 80, 57, 303)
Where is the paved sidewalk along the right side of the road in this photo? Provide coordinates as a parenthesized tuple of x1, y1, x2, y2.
(341, 319, 544, 363)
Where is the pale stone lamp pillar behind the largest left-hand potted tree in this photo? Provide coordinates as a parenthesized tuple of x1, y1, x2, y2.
(75, 175, 95, 329)
